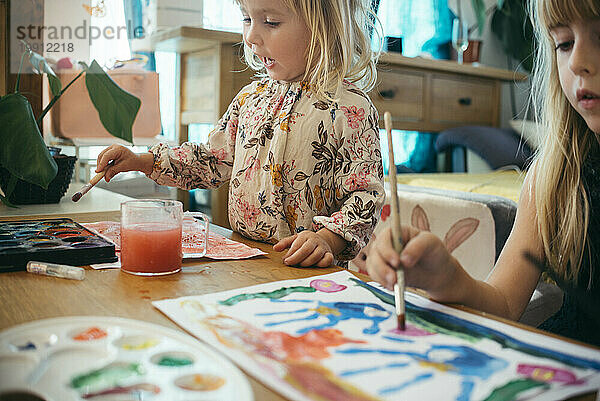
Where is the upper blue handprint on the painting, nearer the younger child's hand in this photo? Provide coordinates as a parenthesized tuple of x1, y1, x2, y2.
(256, 300, 392, 334)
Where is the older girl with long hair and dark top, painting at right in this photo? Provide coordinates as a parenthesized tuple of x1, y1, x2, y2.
(366, 0, 600, 345)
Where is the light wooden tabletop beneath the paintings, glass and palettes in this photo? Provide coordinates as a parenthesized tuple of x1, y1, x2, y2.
(0, 217, 595, 401)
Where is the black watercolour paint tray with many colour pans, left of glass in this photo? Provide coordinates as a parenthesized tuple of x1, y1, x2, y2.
(0, 218, 117, 271)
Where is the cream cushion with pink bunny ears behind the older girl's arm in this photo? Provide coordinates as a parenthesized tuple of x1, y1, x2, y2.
(349, 190, 496, 280)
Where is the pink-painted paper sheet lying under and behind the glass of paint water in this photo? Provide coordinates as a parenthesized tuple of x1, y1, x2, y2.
(83, 216, 266, 268)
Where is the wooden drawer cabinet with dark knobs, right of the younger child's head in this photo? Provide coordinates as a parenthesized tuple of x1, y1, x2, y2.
(369, 54, 527, 132)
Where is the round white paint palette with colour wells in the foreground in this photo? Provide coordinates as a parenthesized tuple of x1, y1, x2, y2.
(0, 316, 253, 401)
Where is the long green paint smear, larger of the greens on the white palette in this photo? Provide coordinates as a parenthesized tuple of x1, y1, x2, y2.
(71, 363, 146, 391)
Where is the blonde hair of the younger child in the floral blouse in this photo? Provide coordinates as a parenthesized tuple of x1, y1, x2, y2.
(236, 0, 381, 101)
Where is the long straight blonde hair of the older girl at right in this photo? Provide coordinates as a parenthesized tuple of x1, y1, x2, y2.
(530, 0, 600, 281)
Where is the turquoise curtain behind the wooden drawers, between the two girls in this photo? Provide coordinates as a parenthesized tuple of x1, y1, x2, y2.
(377, 0, 452, 173)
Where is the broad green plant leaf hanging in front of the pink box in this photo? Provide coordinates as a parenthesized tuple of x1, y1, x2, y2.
(85, 60, 141, 142)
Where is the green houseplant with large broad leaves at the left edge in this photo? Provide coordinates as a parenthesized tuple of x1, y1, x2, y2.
(0, 46, 141, 206)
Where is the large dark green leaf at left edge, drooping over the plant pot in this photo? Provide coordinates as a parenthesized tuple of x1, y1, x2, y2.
(0, 93, 58, 189)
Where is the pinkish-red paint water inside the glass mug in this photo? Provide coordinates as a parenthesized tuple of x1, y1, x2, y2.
(121, 223, 183, 275)
